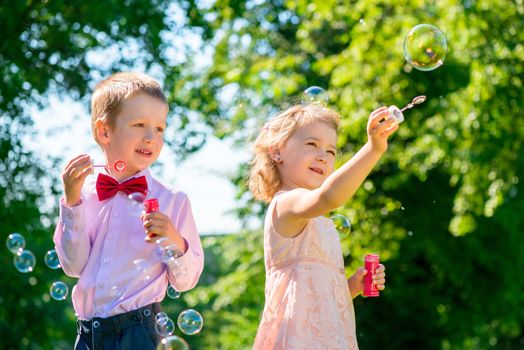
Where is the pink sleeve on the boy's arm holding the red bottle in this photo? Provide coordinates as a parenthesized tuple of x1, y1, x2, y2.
(168, 193, 204, 292)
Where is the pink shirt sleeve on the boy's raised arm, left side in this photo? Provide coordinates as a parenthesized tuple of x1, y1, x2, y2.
(53, 199, 91, 277)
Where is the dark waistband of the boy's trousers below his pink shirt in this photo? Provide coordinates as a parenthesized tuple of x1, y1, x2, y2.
(76, 303, 161, 334)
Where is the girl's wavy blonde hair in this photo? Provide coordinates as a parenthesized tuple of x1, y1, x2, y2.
(248, 104, 340, 203)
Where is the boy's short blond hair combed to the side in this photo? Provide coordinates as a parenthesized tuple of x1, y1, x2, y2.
(91, 72, 167, 144)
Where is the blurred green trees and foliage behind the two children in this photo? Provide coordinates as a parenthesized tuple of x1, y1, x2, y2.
(0, 0, 524, 350)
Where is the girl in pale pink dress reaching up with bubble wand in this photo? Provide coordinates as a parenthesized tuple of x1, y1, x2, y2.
(249, 104, 398, 350)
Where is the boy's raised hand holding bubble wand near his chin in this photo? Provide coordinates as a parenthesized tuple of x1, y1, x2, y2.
(62, 154, 93, 207)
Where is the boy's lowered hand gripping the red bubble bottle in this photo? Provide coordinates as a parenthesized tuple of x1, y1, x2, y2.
(142, 211, 187, 252)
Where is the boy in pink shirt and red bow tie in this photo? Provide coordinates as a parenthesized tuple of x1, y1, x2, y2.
(53, 73, 204, 350)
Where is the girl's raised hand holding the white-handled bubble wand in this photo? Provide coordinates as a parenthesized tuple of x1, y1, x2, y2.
(367, 107, 398, 153)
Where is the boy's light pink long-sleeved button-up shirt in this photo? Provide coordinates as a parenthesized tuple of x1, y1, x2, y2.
(53, 169, 204, 319)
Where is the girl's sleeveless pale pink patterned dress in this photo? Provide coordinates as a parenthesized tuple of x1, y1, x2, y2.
(253, 193, 358, 350)
